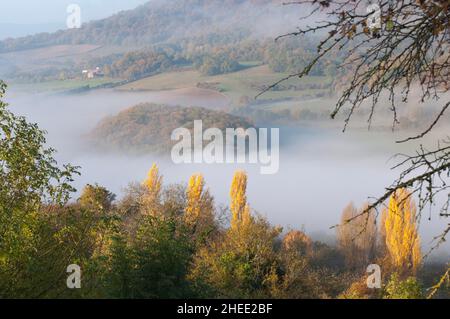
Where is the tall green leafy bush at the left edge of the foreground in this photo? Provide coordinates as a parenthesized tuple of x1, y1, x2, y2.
(0, 81, 77, 298)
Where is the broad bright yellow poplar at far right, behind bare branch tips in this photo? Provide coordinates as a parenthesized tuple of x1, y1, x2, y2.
(383, 189, 422, 273)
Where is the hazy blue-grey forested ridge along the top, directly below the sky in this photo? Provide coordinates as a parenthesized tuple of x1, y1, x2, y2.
(0, 0, 292, 53)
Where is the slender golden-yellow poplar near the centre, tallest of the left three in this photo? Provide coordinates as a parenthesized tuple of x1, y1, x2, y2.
(230, 171, 251, 229)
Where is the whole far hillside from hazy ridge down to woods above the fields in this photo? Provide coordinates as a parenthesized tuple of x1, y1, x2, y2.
(0, 0, 326, 83)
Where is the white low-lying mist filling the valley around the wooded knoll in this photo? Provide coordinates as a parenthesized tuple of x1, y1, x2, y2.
(7, 87, 450, 262)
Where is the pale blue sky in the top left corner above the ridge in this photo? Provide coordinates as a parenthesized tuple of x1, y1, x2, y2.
(0, 0, 148, 39)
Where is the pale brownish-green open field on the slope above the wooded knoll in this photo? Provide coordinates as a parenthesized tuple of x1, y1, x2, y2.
(118, 65, 331, 104)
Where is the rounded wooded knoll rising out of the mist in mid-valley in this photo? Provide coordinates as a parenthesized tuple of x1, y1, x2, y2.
(88, 104, 255, 154)
